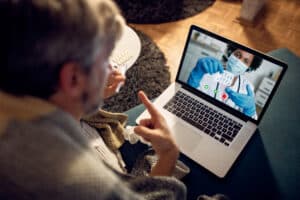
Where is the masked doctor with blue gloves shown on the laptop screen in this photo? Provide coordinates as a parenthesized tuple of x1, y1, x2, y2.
(188, 48, 262, 119)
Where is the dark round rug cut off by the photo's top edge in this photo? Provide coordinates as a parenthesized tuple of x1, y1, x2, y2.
(115, 0, 215, 24)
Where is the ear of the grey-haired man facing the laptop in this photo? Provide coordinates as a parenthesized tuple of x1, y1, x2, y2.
(59, 62, 87, 97)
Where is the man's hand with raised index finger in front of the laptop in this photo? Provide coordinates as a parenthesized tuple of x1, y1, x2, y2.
(134, 92, 179, 176)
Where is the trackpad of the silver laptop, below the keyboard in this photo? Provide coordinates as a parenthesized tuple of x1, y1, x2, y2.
(172, 123, 202, 154)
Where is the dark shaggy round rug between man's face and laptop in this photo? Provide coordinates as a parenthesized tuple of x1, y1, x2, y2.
(103, 30, 171, 112)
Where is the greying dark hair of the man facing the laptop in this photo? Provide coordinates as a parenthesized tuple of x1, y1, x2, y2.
(0, 0, 123, 99)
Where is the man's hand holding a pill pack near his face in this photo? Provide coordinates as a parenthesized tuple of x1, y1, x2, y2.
(104, 66, 126, 99)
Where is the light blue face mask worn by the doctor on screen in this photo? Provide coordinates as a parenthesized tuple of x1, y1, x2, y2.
(226, 54, 248, 76)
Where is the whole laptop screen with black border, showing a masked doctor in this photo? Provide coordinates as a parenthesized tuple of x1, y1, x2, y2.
(177, 26, 286, 121)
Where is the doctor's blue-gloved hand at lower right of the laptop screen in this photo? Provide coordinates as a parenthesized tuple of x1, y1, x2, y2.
(225, 85, 256, 117)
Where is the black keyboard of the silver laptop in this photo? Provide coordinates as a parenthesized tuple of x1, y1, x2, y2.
(164, 91, 242, 146)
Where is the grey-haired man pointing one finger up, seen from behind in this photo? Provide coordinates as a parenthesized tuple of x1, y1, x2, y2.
(0, 0, 186, 200)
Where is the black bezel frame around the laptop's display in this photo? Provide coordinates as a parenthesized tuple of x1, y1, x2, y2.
(176, 25, 288, 125)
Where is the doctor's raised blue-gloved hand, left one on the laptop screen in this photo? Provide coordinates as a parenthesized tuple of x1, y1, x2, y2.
(188, 57, 224, 88)
